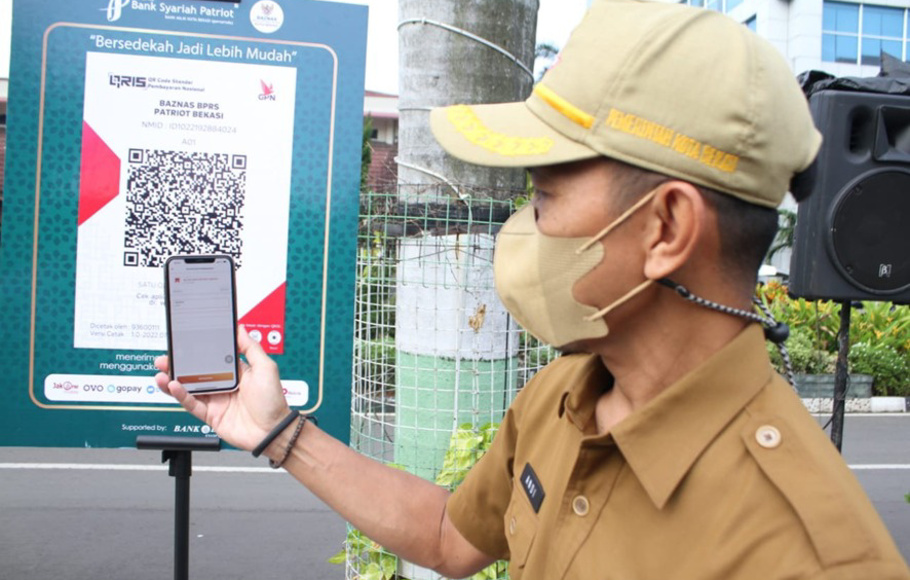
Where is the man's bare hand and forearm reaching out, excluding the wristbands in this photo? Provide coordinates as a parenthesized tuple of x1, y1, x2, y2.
(155, 327, 494, 578)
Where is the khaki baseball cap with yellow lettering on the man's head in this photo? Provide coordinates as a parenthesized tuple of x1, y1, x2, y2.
(430, 0, 821, 207)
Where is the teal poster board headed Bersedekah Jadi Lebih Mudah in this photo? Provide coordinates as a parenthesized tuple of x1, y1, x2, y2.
(0, 0, 368, 449)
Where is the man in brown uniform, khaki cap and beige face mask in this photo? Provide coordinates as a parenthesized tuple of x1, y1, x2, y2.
(157, 0, 910, 580)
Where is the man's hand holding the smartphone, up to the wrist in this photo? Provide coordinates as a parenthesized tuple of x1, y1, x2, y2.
(155, 326, 290, 451)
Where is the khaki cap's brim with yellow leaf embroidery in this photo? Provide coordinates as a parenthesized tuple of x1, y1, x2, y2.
(430, 102, 600, 167)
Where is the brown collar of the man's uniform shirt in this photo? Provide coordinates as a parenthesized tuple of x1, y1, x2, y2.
(560, 324, 774, 509)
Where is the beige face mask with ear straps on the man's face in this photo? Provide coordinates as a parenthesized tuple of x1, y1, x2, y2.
(493, 189, 657, 348)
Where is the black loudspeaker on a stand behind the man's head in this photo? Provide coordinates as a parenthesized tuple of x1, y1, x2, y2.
(790, 91, 910, 304)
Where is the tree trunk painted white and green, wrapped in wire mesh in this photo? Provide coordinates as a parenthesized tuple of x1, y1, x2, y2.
(346, 0, 552, 580)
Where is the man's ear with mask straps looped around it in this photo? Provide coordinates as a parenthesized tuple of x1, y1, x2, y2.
(644, 180, 709, 280)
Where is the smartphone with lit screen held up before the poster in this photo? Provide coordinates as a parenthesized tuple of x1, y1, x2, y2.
(164, 256, 239, 394)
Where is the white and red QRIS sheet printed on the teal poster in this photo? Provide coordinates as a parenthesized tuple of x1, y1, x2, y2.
(73, 52, 297, 354)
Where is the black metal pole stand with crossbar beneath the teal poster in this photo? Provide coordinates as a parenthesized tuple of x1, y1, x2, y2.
(136, 435, 221, 580)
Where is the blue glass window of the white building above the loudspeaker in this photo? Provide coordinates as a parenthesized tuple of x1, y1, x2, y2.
(822, 1, 907, 66)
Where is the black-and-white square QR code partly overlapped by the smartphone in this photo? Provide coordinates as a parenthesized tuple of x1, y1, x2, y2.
(123, 149, 246, 267)
